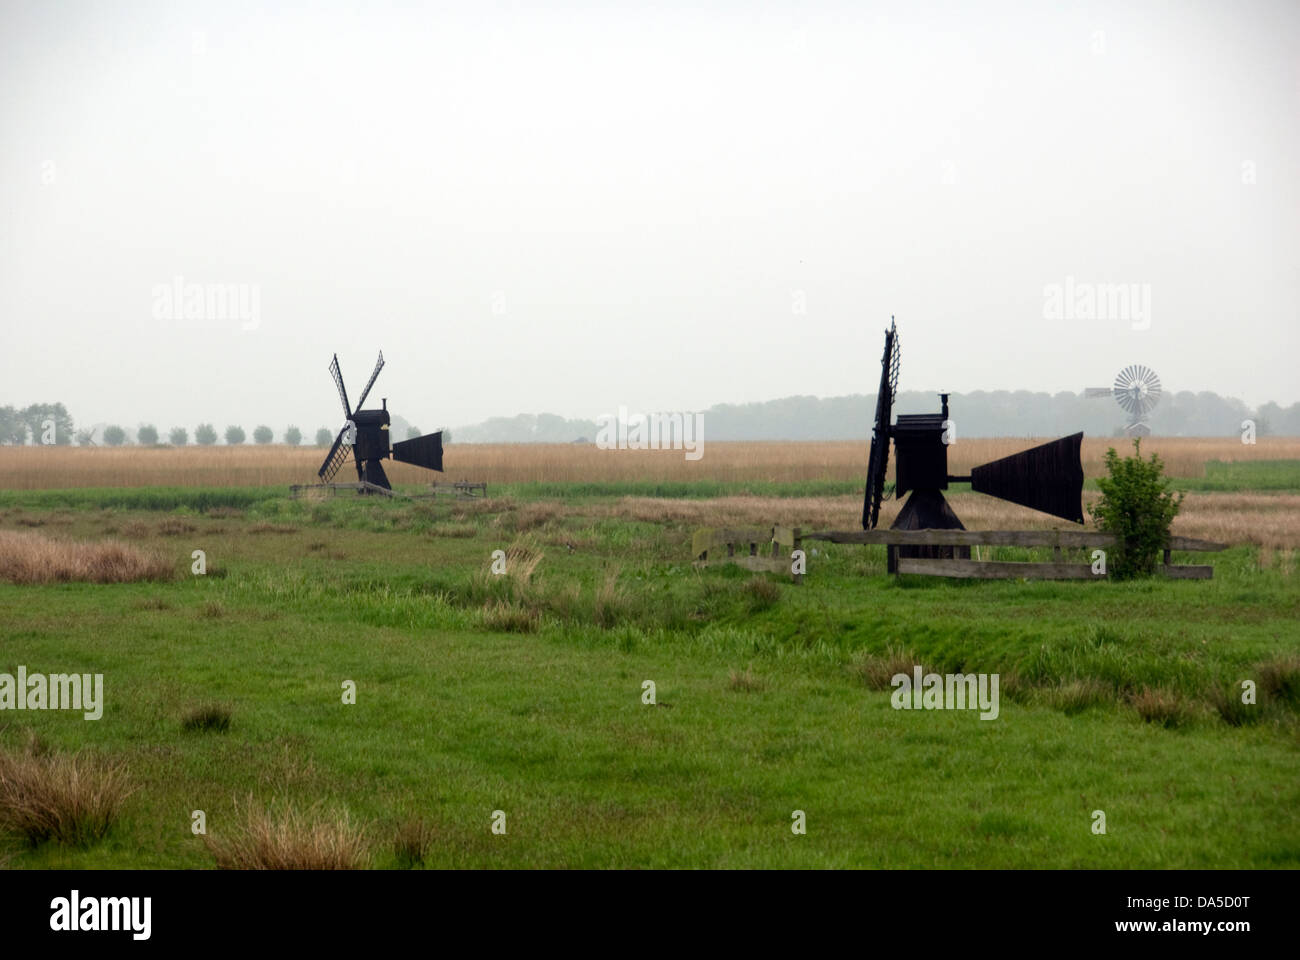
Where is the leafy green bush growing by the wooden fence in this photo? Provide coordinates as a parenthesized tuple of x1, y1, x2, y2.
(1089, 437, 1184, 580)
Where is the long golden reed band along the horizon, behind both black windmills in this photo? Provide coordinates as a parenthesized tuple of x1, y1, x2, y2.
(0, 437, 1300, 489)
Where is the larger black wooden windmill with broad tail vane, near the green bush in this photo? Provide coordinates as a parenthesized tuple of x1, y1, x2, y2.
(862, 320, 1083, 572)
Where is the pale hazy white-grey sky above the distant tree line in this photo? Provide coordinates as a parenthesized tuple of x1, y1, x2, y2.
(0, 0, 1300, 432)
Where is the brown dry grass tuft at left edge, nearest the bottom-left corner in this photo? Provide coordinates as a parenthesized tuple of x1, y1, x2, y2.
(0, 749, 131, 847)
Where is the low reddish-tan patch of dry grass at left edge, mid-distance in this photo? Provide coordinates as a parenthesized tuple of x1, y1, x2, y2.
(0, 529, 174, 584)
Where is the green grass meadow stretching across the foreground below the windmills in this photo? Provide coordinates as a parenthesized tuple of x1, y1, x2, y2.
(0, 455, 1300, 868)
